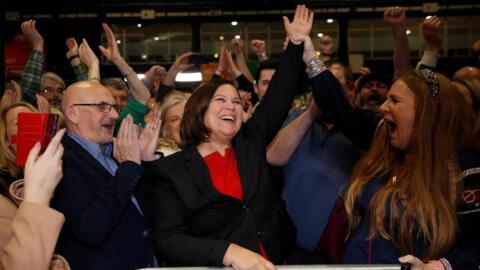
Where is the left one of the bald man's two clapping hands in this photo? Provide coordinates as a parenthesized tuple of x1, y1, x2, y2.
(113, 115, 141, 165)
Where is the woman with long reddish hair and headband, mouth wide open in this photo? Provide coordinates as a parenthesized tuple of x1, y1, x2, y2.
(310, 30, 468, 269)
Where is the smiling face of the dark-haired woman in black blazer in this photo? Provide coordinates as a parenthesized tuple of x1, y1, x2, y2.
(203, 84, 242, 143)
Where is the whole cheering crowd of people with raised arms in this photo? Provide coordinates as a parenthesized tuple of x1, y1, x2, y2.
(0, 5, 480, 270)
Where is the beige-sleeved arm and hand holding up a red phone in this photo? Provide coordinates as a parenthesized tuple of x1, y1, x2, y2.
(0, 130, 70, 270)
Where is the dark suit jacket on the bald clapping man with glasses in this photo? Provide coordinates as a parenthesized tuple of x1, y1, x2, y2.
(52, 135, 153, 270)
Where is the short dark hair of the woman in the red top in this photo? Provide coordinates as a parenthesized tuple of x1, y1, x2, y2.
(180, 79, 233, 146)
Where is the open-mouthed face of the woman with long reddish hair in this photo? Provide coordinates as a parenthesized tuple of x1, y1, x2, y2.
(380, 80, 415, 151)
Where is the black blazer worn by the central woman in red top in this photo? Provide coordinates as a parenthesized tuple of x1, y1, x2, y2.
(151, 44, 304, 266)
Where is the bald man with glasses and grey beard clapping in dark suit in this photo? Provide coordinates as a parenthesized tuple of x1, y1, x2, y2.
(53, 81, 158, 270)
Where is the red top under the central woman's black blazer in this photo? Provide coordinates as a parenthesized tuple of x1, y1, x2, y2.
(203, 148, 268, 260)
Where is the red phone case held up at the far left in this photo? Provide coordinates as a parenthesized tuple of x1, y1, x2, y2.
(16, 113, 59, 166)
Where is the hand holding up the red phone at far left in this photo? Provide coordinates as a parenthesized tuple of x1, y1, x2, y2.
(24, 129, 65, 205)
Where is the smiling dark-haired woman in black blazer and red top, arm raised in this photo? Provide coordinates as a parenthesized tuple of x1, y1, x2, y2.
(151, 6, 316, 269)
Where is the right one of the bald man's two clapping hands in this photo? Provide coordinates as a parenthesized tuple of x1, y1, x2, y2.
(138, 110, 162, 161)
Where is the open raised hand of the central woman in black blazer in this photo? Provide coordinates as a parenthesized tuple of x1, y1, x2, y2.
(283, 5, 313, 45)
